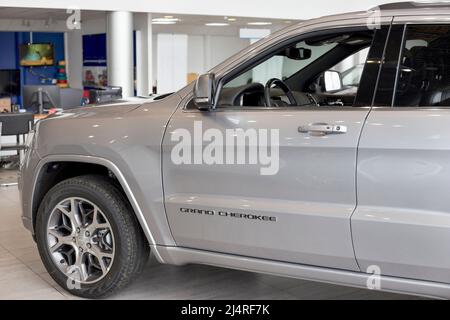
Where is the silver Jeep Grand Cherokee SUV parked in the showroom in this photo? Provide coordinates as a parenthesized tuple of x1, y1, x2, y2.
(20, 3, 450, 298)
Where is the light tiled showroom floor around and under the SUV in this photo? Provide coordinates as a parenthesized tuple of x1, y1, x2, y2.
(0, 170, 424, 299)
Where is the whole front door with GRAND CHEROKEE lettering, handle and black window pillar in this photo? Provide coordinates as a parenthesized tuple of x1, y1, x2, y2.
(163, 27, 387, 270)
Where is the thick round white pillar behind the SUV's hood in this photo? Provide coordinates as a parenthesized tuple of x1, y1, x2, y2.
(106, 11, 134, 98)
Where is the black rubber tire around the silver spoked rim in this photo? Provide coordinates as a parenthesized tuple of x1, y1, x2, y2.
(36, 175, 150, 299)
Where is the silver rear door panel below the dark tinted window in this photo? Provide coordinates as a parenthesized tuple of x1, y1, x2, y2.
(352, 108, 450, 283)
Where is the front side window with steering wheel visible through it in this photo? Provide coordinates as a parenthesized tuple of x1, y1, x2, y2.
(217, 28, 375, 108)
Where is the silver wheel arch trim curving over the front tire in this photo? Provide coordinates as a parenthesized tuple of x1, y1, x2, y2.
(30, 155, 163, 262)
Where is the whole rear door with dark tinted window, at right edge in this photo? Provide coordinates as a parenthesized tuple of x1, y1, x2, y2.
(352, 17, 450, 283)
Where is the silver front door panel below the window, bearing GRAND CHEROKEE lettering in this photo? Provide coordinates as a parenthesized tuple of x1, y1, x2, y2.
(163, 107, 369, 270)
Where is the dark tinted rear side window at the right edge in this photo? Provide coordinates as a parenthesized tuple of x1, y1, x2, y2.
(394, 25, 450, 107)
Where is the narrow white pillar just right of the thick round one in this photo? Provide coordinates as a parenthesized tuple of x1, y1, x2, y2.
(134, 13, 153, 96)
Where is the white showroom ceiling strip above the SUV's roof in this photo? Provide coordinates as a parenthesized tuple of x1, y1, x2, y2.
(0, 0, 400, 19)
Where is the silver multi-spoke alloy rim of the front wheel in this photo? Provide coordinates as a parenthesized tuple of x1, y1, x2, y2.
(47, 197, 115, 284)
